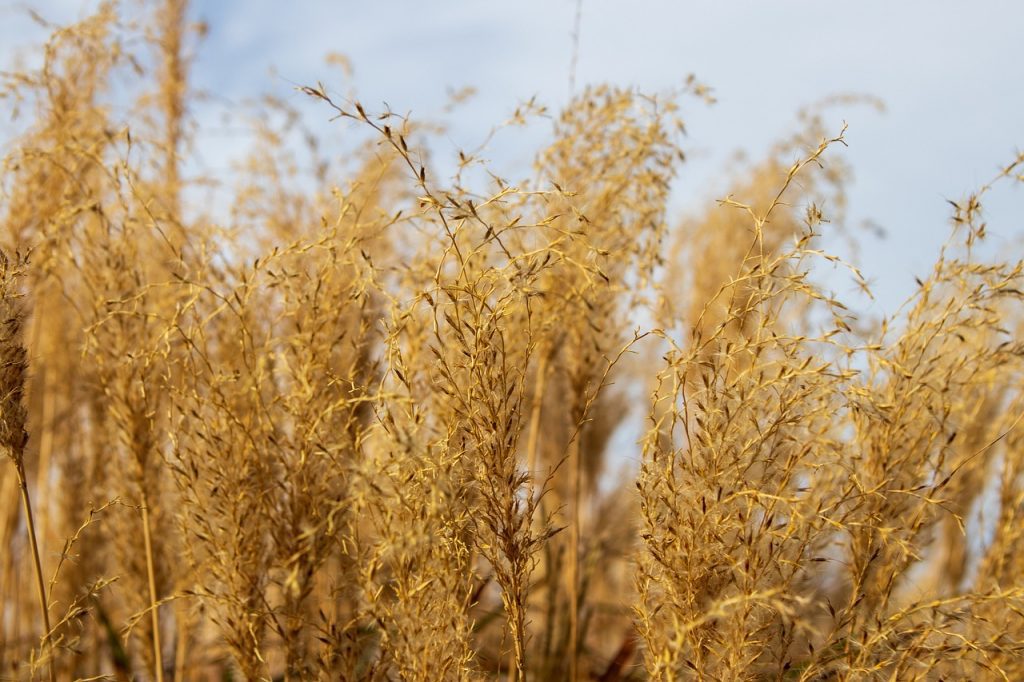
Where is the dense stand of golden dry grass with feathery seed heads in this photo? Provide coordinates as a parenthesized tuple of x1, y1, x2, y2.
(0, 0, 1024, 682)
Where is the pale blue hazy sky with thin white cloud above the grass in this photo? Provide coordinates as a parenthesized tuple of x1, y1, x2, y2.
(0, 0, 1024, 313)
